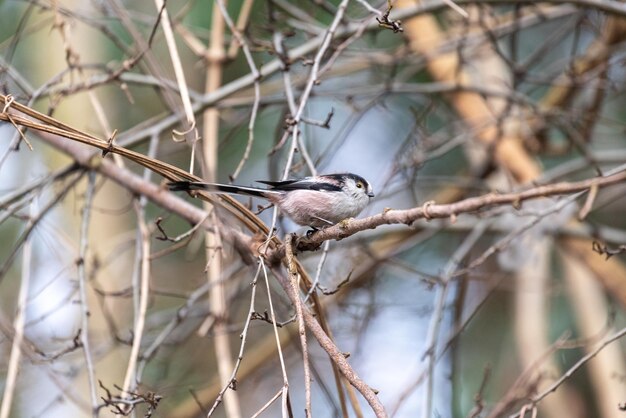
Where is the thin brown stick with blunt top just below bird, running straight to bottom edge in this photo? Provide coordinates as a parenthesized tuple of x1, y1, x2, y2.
(285, 235, 312, 418)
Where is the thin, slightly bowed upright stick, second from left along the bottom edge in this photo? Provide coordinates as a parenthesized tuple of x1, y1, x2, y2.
(77, 171, 98, 418)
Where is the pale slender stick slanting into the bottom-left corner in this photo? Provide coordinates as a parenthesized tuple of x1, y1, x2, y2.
(0, 199, 37, 418)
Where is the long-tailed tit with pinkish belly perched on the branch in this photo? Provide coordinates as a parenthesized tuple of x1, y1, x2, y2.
(168, 173, 374, 229)
